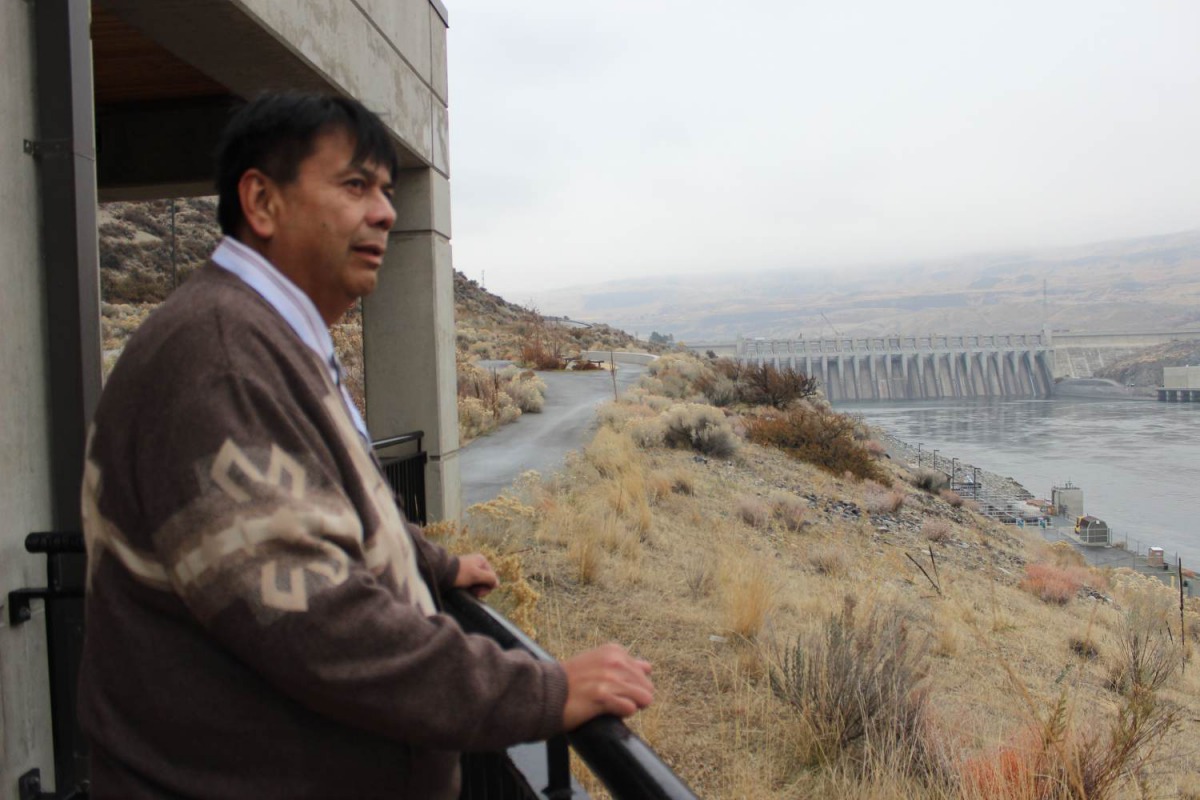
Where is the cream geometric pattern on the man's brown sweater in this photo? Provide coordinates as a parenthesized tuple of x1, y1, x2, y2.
(83, 395, 437, 621)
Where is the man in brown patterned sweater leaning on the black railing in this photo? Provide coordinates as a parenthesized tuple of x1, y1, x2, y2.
(80, 94, 652, 798)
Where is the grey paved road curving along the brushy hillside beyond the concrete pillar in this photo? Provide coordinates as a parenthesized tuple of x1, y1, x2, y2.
(458, 363, 646, 507)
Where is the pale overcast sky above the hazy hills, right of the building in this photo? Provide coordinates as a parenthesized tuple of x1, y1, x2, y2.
(446, 0, 1200, 301)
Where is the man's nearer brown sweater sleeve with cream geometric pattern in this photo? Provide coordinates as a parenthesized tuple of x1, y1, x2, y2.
(138, 375, 566, 751)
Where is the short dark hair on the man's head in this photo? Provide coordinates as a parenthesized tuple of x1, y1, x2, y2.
(217, 91, 400, 236)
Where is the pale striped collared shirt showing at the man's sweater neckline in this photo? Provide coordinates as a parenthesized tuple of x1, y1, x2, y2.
(212, 236, 371, 451)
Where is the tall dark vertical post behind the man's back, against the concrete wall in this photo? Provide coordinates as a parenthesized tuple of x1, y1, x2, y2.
(26, 0, 101, 795)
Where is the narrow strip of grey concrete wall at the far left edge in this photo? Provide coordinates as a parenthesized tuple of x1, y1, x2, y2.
(0, 2, 54, 798)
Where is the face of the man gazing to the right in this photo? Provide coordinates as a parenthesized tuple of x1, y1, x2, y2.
(268, 131, 396, 324)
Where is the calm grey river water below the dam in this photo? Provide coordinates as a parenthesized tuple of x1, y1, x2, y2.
(836, 398, 1200, 567)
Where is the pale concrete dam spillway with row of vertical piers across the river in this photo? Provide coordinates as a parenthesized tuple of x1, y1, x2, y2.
(736, 333, 1054, 401)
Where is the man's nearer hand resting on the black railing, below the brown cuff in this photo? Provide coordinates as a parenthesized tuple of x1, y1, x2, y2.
(563, 644, 654, 730)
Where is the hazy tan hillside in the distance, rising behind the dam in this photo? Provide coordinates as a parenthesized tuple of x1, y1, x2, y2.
(535, 230, 1200, 343)
